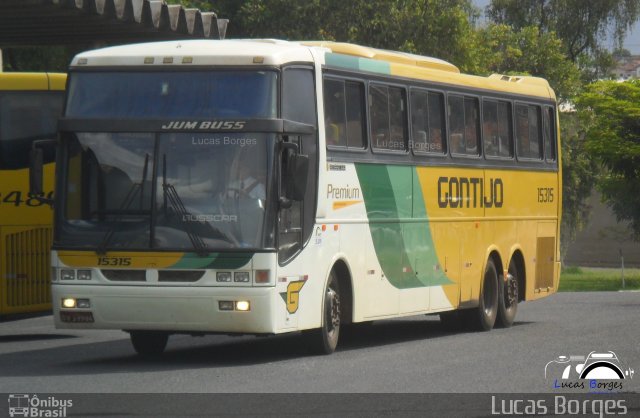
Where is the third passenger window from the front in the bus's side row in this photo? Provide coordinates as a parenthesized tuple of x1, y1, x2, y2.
(410, 91, 445, 154)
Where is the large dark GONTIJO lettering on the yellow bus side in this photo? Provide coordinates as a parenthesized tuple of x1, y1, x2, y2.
(438, 176, 504, 209)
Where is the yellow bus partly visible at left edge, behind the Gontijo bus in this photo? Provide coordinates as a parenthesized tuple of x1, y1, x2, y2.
(0, 72, 66, 315)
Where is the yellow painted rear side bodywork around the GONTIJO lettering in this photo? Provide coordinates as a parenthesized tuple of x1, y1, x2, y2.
(416, 167, 561, 307)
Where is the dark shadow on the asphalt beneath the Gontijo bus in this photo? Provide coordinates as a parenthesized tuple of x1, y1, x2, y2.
(0, 317, 527, 376)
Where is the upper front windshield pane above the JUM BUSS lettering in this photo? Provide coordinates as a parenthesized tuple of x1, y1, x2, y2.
(65, 70, 278, 119)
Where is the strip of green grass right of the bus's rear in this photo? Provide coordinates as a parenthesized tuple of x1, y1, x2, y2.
(559, 267, 640, 292)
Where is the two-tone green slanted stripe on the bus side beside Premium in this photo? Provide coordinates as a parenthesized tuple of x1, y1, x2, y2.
(356, 164, 452, 289)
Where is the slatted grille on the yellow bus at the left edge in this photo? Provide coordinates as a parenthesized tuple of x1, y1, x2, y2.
(0, 228, 51, 311)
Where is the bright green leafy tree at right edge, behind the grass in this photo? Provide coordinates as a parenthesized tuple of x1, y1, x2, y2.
(576, 80, 640, 240)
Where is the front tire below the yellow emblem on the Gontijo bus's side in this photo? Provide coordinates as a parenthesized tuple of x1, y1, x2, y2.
(312, 271, 340, 354)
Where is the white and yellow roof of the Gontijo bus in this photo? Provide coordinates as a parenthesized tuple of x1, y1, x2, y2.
(71, 39, 555, 100)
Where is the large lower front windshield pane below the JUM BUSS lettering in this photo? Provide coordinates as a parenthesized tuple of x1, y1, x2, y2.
(57, 132, 276, 252)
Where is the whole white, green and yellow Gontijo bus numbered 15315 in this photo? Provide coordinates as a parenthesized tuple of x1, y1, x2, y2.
(38, 40, 561, 354)
